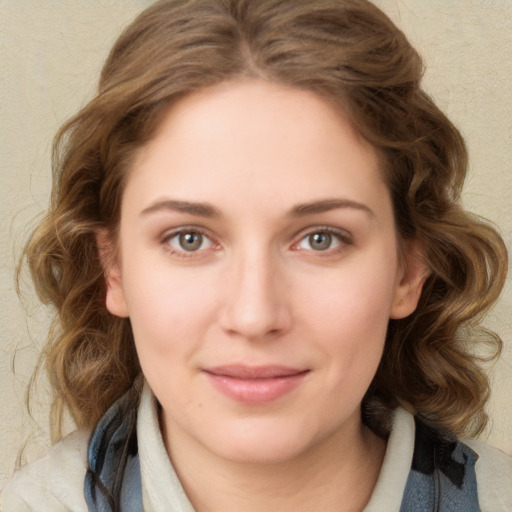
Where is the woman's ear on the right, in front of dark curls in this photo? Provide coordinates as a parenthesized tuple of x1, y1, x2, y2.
(389, 240, 429, 319)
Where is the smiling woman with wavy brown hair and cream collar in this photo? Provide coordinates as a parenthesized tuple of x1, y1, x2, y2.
(3, 0, 512, 512)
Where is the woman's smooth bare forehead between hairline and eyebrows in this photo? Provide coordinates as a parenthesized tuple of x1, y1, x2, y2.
(125, 80, 385, 218)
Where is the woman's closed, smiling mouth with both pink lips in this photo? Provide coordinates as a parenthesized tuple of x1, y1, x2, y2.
(203, 365, 310, 405)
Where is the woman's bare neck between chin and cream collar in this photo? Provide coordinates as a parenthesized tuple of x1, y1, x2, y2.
(166, 412, 386, 512)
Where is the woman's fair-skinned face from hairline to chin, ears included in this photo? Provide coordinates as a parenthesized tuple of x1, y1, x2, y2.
(107, 81, 421, 462)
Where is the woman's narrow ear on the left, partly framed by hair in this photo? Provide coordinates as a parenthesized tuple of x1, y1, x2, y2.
(96, 229, 129, 318)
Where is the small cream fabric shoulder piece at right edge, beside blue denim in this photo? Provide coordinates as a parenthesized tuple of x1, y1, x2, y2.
(463, 439, 512, 511)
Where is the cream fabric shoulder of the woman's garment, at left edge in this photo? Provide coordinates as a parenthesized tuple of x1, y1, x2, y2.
(1, 431, 89, 512)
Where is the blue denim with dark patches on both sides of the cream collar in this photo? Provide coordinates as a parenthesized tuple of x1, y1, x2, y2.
(84, 389, 480, 512)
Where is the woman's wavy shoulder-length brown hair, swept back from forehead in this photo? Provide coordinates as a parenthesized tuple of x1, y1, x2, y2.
(20, 0, 507, 435)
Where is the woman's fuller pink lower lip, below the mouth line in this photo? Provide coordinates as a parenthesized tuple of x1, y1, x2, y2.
(205, 372, 308, 405)
